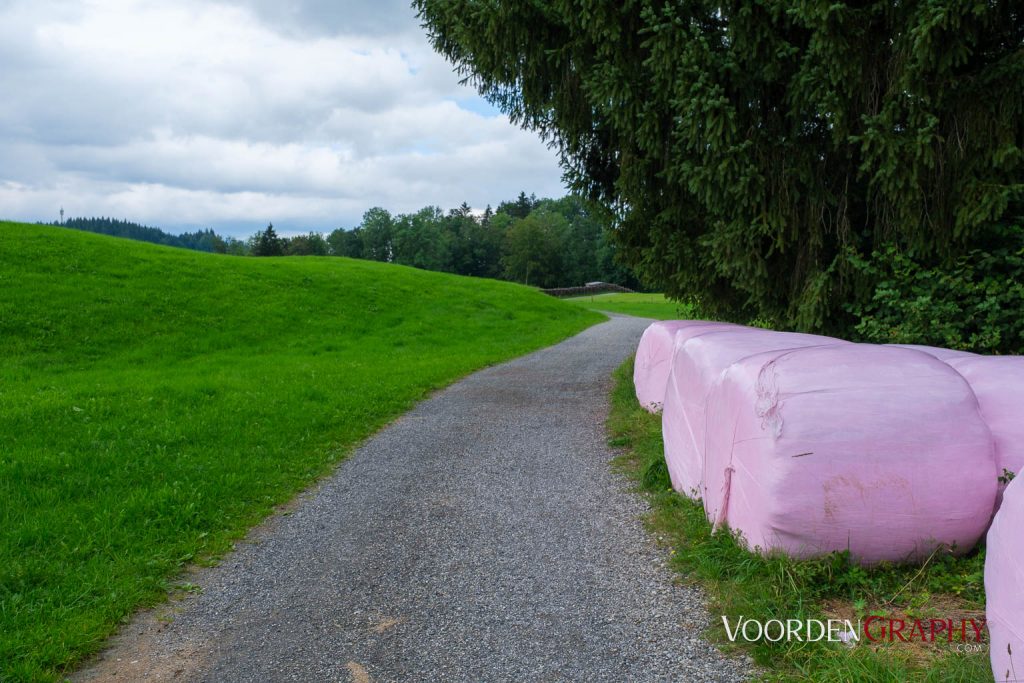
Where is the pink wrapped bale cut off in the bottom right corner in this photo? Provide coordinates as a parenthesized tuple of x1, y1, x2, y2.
(985, 480, 1024, 681)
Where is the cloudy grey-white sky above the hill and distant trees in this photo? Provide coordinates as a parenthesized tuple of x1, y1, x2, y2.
(0, 0, 564, 236)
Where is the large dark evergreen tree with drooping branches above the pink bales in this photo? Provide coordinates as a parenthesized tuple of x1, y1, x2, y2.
(414, 0, 1024, 330)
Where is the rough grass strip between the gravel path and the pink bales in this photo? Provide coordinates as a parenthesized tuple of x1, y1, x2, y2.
(607, 358, 992, 682)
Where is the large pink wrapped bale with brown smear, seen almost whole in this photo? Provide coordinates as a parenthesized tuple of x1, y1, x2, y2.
(703, 344, 996, 563)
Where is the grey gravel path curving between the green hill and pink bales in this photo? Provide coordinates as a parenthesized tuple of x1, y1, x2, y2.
(76, 316, 750, 683)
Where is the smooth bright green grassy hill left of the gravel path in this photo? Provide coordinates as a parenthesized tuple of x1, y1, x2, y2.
(0, 222, 600, 680)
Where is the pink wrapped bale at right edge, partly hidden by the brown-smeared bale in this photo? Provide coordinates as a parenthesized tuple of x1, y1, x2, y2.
(946, 354, 1024, 507)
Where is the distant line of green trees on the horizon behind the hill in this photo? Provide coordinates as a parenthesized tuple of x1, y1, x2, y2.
(49, 193, 640, 289)
